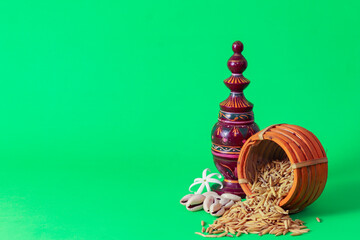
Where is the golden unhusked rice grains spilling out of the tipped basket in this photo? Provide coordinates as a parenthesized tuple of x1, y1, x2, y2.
(196, 159, 309, 237)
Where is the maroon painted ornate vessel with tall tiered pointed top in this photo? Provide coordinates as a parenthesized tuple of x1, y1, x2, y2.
(211, 41, 259, 196)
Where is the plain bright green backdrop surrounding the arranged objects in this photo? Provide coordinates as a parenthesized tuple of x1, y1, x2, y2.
(0, 0, 360, 240)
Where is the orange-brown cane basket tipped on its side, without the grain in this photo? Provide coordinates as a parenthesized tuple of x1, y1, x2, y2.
(237, 124, 328, 213)
